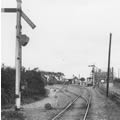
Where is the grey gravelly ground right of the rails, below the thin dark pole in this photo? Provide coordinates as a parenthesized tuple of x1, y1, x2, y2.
(88, 88, 120, 120)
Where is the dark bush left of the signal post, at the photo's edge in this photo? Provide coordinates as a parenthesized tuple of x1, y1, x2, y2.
(1, 67, 15, 105)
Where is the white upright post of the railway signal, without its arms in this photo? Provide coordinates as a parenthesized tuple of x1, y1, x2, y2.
(15, 0, 22, 110)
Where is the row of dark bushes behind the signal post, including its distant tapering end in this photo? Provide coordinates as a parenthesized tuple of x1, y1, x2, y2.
(1, 65, 63, 106)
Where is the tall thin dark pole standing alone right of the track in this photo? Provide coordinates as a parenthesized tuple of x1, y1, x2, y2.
(106, 33, 112, 97)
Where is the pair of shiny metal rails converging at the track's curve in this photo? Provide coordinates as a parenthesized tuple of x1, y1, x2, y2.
(51, 88, 91, 120)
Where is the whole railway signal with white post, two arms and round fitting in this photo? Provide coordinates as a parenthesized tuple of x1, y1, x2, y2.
(1, 0, 36, 110)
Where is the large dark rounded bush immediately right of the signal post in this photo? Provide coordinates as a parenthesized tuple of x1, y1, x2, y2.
(22, 69, 45, 100)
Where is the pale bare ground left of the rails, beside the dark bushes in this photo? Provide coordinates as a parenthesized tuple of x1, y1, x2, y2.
(23, 86, 82, 120)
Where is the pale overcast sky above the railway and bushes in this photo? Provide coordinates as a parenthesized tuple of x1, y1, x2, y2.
(1, 0, 120, 77)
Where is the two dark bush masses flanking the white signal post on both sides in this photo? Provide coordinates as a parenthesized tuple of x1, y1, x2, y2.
(1, 66, 45, 106)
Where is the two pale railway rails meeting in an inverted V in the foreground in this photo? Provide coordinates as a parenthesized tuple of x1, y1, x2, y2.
(51, 88, 91, 120)
